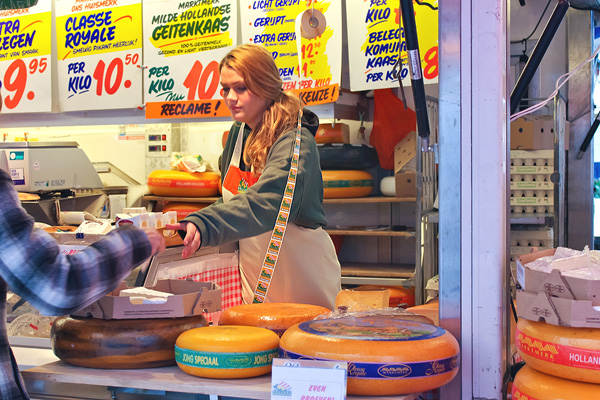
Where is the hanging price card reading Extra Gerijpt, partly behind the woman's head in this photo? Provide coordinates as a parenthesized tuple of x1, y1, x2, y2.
(240, 0, 342, 105)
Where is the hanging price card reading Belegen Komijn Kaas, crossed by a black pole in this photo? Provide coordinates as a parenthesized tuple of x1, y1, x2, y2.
(346, 0, 438, 91)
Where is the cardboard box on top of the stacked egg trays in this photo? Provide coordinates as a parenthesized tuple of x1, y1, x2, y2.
(510, 115, 569, 150)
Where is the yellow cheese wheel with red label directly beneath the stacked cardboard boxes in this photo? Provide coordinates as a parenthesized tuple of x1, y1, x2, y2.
(516, 318, 600, 384)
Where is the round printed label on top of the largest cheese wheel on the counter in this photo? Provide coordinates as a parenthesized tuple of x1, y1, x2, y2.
(298, 316, 446, 341)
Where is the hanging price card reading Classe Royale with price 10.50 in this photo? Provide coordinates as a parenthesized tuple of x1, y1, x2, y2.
(56, 0, 143, 111)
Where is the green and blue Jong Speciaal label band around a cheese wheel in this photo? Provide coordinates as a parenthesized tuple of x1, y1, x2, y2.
(175, 345, 279, 369)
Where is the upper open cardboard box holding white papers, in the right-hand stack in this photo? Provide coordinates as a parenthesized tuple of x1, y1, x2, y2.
(517, 249, 600, 306)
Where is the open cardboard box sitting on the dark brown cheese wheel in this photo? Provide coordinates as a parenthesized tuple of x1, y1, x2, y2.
(71, 279, 221, 319)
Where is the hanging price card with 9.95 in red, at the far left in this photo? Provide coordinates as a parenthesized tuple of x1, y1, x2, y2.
(0, 1, 52, 113)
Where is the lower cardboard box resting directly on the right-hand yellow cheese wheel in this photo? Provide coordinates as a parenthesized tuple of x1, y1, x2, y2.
(517, 290, 600, 328)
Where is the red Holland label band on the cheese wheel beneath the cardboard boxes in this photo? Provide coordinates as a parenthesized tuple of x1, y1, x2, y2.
(516, 329, 600, 371)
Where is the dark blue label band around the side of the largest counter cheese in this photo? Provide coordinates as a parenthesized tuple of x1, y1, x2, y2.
(282, 349, 458, 379)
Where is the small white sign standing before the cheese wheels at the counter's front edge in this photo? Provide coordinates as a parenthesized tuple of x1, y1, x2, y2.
(271, 358, 348, 400)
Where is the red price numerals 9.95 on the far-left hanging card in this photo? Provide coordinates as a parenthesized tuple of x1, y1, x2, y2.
(1, 57, 49, 111)
